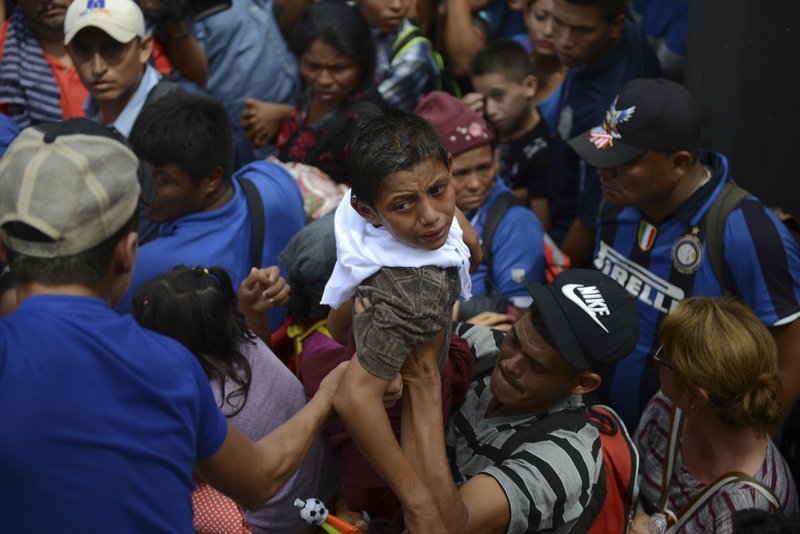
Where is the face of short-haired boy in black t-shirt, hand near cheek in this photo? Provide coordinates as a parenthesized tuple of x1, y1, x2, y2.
(472, 73, 536, 139)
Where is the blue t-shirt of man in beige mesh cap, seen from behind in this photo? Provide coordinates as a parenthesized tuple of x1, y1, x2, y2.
(0, 295, 227, 533)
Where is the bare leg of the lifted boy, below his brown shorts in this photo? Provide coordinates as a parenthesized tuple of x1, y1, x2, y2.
(333, 355, 446, 532)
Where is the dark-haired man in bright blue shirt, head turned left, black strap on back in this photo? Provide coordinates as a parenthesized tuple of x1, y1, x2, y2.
(117, 91, 305, 329)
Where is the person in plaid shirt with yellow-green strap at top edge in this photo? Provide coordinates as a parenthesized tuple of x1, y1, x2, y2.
(356, 0, 439, 111)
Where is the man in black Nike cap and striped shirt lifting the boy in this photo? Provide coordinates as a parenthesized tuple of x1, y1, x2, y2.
(401, 269, 639, 533)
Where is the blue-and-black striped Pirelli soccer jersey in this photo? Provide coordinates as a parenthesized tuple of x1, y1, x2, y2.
(594, 152, 800, 428)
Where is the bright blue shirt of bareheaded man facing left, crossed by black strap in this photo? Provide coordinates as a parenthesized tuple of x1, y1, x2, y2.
(117, 161, 305, 329)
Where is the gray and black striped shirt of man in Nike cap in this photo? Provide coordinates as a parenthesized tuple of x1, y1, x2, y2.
(447, 327, 602, 533)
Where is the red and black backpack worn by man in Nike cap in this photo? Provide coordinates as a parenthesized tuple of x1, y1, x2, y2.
(500, 404, 639, 534)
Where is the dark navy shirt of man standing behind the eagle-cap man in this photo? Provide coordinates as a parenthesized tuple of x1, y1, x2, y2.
(548, 21, 661, 244)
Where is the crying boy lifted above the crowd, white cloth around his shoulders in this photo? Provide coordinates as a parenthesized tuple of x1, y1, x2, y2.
(322, 110, 470, 532)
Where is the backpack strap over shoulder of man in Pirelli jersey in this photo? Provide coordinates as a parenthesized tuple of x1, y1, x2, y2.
(705, 182, 750, 293)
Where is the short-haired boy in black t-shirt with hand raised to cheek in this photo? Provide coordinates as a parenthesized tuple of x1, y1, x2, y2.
(464, 39, 550, 229)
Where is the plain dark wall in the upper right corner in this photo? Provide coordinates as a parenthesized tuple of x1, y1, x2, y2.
(684, 0, 800, 215)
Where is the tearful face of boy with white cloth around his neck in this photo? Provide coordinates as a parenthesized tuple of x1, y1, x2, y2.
(353, 160, 456, 250)
